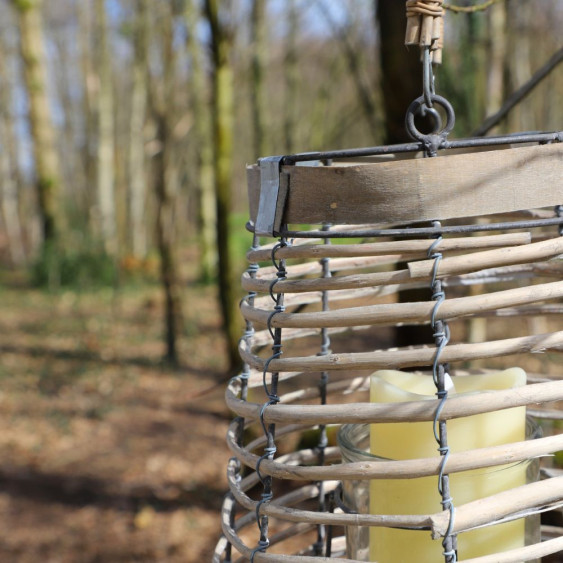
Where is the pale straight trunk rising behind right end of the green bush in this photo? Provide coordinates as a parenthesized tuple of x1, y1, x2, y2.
(95, 0, 117, 255)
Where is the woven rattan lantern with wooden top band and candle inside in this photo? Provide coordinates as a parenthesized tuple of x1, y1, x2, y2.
(215, 5, 563, 563)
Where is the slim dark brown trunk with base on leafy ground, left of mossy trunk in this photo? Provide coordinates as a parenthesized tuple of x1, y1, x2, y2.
(149, 1, 183, 365)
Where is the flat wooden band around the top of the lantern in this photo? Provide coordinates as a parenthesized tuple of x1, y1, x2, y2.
(247, 143, 563, 224)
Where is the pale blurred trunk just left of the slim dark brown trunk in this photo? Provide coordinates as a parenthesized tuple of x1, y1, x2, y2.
(128, 0, 148, 258)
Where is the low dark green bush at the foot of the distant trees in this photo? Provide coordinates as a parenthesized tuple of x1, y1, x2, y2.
(31, 241, 118, 290)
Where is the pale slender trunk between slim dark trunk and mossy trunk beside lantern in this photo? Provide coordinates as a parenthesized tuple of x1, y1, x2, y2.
(186, 0, 218, 281)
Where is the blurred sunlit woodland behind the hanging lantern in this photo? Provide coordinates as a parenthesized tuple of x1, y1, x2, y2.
(0, 0, 563, 563)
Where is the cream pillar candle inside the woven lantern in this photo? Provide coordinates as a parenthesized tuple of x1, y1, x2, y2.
(370, 368, 526, 563)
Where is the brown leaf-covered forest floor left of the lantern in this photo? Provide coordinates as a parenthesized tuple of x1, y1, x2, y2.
(0, 262, 231, 563)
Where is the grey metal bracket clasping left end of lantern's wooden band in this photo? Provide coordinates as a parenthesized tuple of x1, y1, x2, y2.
(255, 156, 287, 236)
